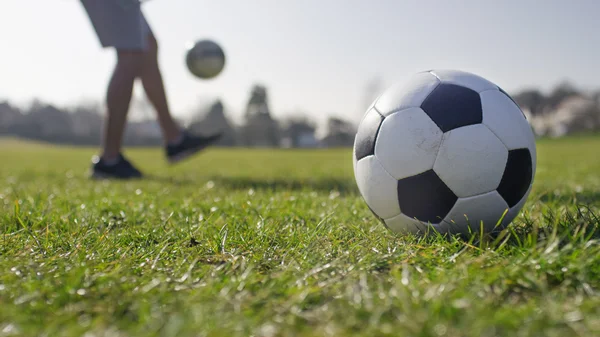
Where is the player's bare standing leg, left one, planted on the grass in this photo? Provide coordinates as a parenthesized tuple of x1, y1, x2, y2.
(102, 51, 143, 161)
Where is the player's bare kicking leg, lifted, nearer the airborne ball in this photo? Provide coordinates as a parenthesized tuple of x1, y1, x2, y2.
(140, 33, 182, 143)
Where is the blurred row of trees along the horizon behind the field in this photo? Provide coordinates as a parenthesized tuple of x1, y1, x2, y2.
(0, 82, 600, 148)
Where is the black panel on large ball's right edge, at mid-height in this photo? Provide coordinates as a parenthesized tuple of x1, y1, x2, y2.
(496, 149, 533, 207)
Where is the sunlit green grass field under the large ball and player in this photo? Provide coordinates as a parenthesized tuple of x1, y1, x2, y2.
(0, 137, 600, 337)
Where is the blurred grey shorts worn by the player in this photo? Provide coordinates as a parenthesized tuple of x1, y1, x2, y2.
(81, 0, 151, 50)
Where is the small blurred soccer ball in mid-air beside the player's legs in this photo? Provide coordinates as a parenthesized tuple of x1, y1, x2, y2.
(185, 40, 225, 79)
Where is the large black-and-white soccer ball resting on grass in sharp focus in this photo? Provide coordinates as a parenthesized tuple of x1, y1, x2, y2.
(353, 70, 536, 234)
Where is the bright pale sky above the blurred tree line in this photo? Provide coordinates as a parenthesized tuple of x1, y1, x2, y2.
(0, 0, 600, 126)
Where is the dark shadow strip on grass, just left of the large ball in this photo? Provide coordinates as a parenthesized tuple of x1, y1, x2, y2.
(204, 176, 358, 194)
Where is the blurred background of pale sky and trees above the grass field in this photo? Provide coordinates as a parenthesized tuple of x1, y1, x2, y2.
(0, 0, 600, 147)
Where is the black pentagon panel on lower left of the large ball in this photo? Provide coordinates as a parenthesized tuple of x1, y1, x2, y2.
(398, 170, 458, 224)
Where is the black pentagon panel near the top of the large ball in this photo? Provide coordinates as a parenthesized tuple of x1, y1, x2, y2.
(421, 83, 483, 132)
